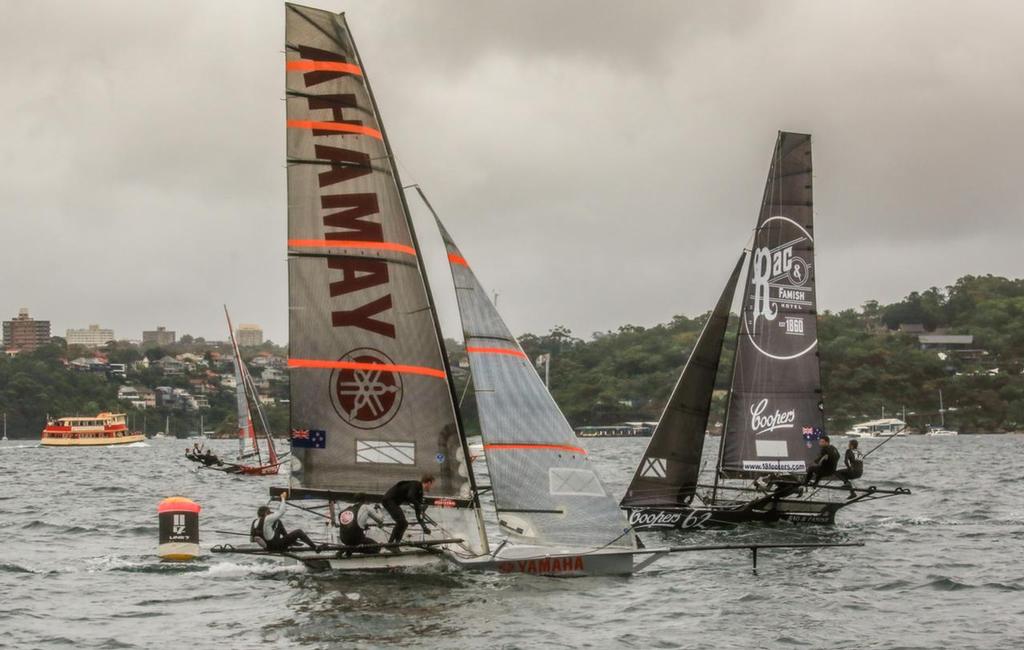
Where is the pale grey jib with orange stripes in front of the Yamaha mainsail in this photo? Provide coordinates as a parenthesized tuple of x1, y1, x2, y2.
(435, 205, 635, 549)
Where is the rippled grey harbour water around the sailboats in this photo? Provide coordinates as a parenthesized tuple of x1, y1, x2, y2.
(0, 435, 1024, 649)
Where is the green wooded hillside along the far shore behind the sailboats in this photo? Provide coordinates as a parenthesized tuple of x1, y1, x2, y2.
(0, 275, 1024, 438)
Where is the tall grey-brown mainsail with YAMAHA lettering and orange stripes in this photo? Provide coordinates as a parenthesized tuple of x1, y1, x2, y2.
(286, 4, 476, 524)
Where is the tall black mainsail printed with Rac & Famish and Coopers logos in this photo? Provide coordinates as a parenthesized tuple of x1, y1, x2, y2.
(720, 132, 823, 477)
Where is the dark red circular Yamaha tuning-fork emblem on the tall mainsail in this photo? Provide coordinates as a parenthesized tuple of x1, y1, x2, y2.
(331, 348, 402, 429)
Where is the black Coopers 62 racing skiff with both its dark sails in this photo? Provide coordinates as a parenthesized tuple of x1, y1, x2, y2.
(622, 132, 906, 530)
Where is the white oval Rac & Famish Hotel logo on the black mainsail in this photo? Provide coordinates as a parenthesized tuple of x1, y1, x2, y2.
(743, 216, 817, 360)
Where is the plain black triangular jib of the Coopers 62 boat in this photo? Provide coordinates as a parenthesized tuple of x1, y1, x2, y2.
(622, 255, 743, 507)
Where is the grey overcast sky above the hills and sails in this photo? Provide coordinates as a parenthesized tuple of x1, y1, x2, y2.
(0, 0, 1024, 342)
